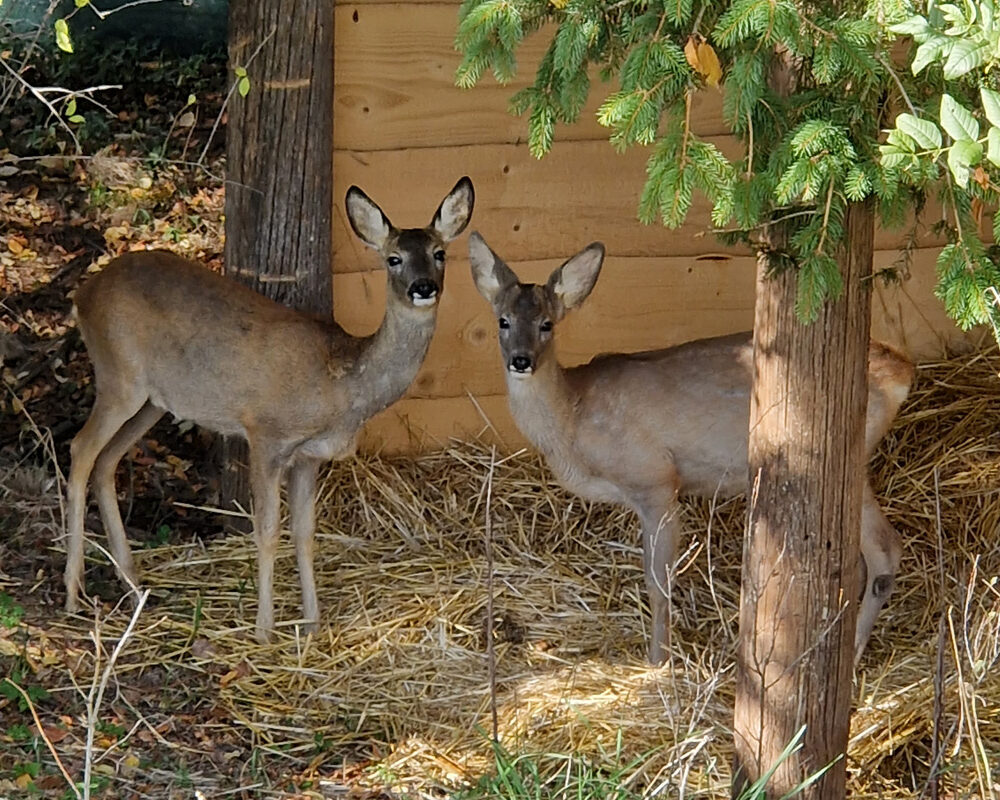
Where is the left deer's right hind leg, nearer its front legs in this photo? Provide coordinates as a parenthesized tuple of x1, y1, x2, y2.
(93, 400, 164, 604)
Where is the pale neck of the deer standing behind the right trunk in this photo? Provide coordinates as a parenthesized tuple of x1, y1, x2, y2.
(507, 354, 576, 462)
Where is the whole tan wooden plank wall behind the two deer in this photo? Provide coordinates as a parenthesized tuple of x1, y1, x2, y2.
(334, 0, 984, 452)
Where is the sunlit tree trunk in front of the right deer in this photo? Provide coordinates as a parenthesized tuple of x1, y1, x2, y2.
(733, 195, 874, 800)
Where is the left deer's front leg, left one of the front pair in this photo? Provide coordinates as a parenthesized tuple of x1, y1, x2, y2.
(250, 441, 281, 644)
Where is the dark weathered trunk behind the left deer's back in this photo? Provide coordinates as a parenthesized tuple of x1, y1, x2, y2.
(221, 0, 333, 528)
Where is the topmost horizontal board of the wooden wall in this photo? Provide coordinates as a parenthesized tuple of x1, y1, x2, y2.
(334, 3, 728, 151)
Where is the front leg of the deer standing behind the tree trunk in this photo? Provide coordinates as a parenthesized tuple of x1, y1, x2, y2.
(638, 484, 679, 666)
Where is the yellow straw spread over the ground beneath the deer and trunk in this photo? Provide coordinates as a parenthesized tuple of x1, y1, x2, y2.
(48, 354, 1000, 798)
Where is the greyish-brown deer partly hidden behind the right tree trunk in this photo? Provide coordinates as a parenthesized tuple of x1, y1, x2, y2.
(469, 233, 914, 664)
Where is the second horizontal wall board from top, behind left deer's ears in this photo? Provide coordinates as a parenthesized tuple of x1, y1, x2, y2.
(334, 142, 939, 272)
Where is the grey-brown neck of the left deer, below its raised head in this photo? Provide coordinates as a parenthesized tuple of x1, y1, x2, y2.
(351, 294, 437, 421)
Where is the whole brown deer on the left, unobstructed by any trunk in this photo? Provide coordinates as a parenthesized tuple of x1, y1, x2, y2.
(66, 178, 474, 641)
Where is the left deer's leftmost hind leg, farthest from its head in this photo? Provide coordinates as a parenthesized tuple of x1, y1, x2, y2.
(65, 393, 146, 613)
